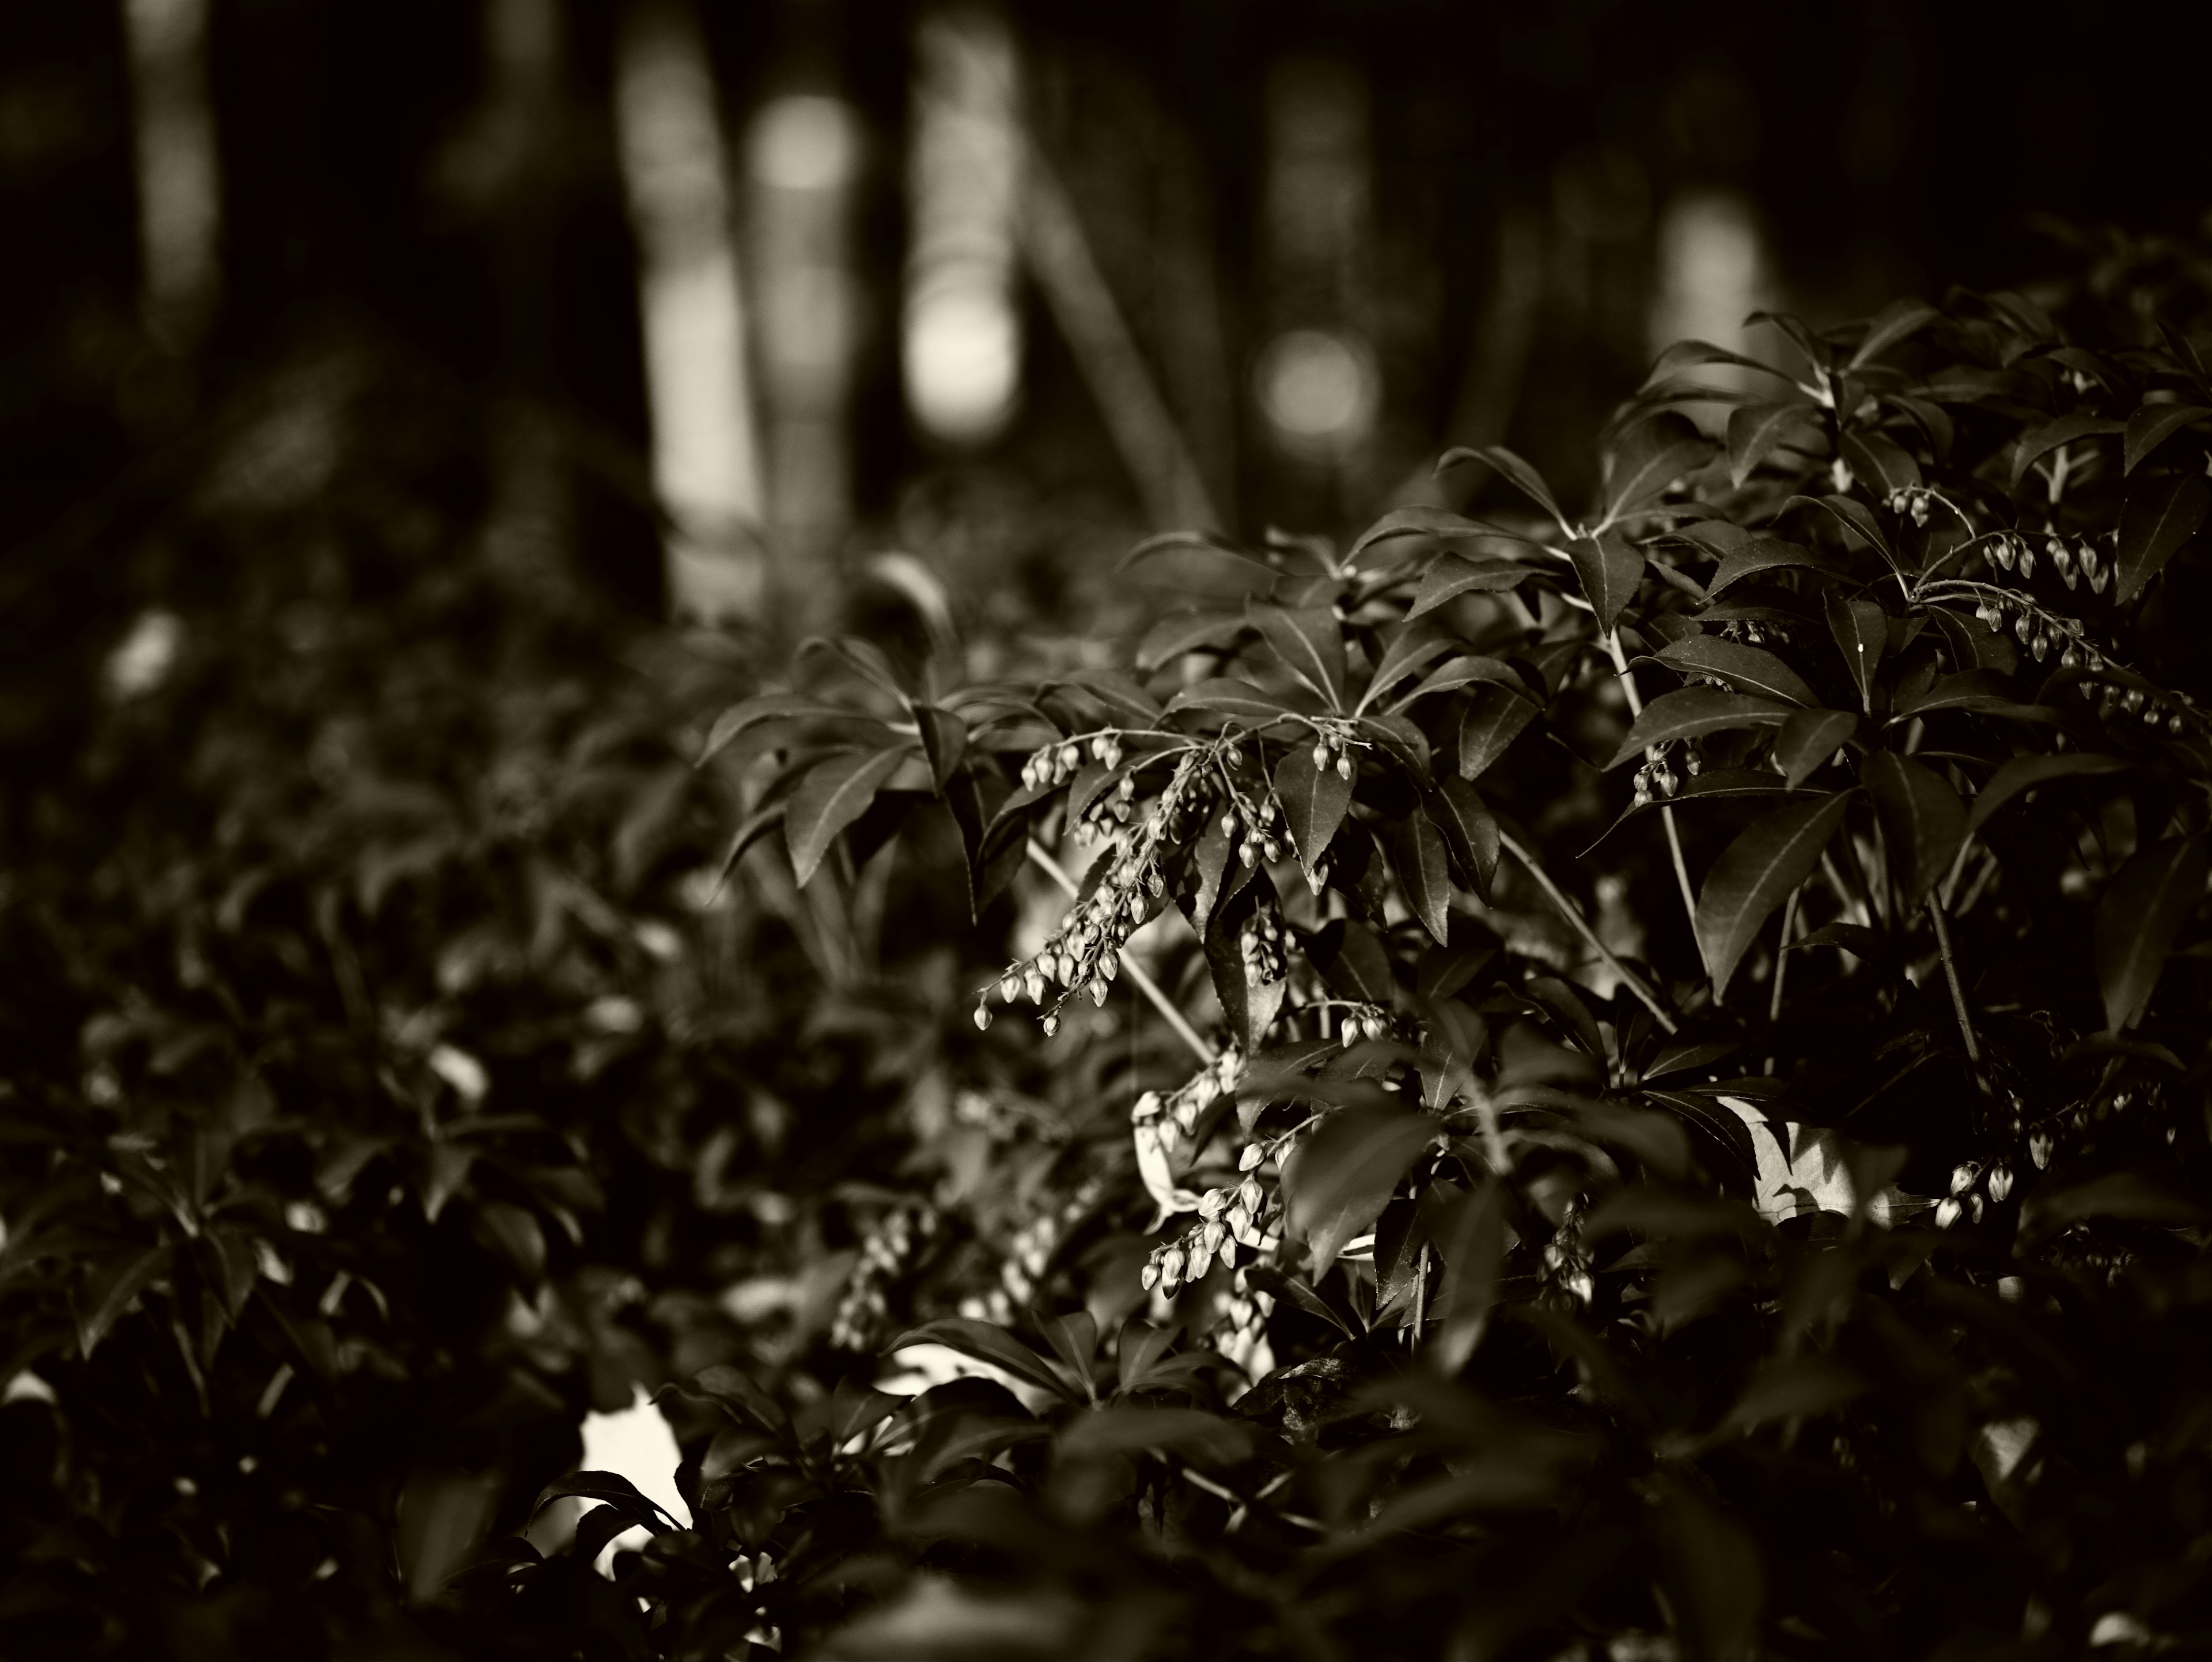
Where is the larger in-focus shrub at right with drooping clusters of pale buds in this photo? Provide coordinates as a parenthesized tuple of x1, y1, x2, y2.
(502, 266, 2212, 1657)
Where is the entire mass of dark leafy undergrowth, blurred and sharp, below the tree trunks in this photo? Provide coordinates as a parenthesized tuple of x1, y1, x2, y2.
(13, 248, 2212, 1657)
